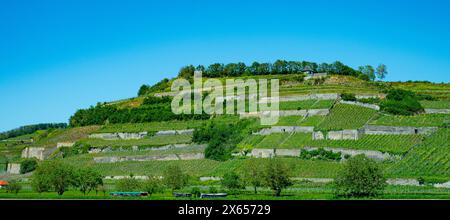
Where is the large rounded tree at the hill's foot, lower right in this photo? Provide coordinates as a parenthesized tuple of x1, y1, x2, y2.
(334, 154, 386, 197)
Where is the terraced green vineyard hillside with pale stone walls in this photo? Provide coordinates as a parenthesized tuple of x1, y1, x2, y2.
(0, 72, 450, 199)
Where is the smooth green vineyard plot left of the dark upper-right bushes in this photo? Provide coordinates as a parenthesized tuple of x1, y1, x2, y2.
(317, 104, 377, 130)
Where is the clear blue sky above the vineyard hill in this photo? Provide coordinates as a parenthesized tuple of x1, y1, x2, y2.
(0, 0, 450, 131)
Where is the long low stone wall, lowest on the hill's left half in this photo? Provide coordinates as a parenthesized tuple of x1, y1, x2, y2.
(94, 153, 205, 163)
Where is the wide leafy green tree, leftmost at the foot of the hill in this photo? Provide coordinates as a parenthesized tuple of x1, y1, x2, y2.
(32, 160, 75, 195)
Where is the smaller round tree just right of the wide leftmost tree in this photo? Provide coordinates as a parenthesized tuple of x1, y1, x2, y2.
(74, 168, 103, 195)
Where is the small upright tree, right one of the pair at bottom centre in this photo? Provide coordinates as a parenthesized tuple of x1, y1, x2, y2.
(264, 159, 292, 196)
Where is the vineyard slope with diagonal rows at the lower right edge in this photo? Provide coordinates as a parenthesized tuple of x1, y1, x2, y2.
(389, 128, 450, 178)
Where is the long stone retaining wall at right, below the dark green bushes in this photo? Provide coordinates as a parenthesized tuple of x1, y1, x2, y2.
(364, 125, 438, 135)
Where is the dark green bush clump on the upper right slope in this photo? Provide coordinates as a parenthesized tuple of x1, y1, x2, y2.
(380, 89, 423, 115)
